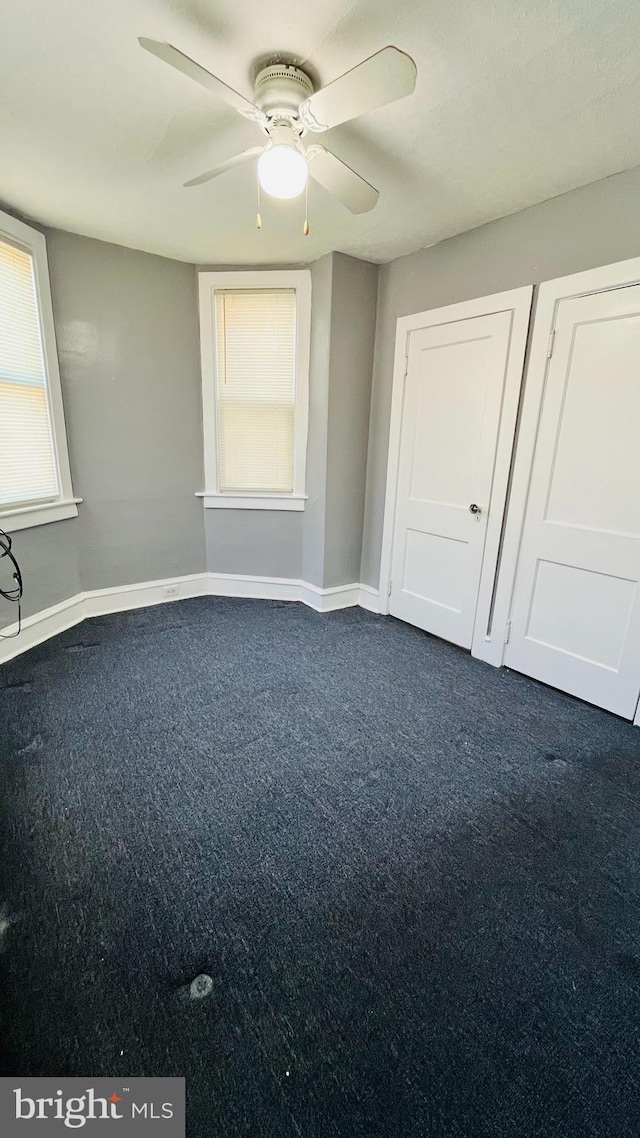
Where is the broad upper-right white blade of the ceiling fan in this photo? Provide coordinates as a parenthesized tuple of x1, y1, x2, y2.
(298, 48, 417, 131)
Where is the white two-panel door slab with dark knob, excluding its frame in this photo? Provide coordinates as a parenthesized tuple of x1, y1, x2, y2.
(389, 311, 512, 648)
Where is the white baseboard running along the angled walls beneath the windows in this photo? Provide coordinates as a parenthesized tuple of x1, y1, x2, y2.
(0, 572, 379, 663)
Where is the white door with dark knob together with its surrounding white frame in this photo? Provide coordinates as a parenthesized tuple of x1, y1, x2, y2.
(380, 287, 532, 665)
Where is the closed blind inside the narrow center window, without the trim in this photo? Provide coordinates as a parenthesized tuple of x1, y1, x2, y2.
(215, 289, 296, 494)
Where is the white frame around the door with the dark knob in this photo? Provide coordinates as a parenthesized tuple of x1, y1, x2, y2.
(379, 285, 533, 665)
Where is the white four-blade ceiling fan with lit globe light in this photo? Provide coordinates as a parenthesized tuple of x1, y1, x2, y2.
(139, 36, 416, 217)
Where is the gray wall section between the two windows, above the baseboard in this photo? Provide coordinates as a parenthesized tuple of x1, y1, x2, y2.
(46, 230, 205, 589)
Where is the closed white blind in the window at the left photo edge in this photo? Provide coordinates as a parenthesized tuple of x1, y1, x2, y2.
(0, 241, 58, 509)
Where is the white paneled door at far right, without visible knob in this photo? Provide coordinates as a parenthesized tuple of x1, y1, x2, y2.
(504, 286, 640, 718)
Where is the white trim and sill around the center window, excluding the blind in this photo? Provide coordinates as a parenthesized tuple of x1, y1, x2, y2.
(197, 269, 311, 510)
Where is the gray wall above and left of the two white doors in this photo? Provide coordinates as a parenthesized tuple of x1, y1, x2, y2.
(360, 167, 640, 587)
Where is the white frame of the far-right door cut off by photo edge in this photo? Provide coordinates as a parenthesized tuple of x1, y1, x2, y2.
(493, 257, 640, 727)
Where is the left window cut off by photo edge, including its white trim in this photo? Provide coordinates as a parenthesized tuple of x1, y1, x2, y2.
(0, 213, 77, 530)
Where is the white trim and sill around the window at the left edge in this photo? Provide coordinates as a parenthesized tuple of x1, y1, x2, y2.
(0, 212, 82, 533)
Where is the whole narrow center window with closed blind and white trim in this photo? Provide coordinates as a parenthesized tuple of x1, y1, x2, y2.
(199, 271, 311, 510)
